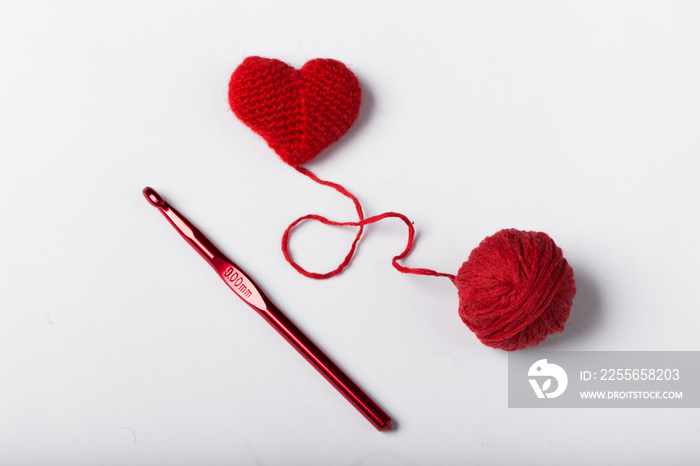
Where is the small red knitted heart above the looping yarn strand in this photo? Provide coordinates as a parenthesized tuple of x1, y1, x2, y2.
(229, 57, 362, 167)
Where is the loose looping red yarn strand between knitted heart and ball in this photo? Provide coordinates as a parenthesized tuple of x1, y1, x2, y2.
(282, 167, 455, 283)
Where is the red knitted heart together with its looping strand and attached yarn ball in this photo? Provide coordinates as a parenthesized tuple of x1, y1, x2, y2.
(229, 57, 576, 351)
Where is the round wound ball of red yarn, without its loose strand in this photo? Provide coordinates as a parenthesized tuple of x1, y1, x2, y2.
(455, 229, 576, 351)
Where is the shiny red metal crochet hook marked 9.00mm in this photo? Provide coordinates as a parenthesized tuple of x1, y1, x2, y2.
(143, 187, 391, 431)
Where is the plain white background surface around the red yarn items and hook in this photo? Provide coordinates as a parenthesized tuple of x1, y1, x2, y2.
(0, 1, 700, 465)
